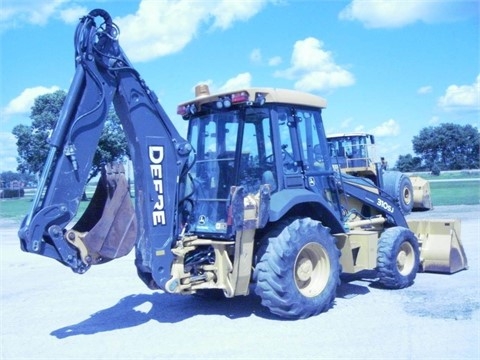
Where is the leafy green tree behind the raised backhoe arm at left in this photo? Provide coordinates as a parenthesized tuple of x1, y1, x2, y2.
(13, 90, 128, 180)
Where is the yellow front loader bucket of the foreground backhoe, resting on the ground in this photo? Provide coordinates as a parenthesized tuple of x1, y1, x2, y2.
(408, 220, 468, 274)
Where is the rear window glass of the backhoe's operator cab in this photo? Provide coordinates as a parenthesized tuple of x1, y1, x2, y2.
(186, 107, 274, 238)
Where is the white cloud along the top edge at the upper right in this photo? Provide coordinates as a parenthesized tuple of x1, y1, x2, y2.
(339, 0, 478, 28)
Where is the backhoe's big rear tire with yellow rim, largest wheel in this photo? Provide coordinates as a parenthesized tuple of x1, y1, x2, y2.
(254, 218, 341, 319)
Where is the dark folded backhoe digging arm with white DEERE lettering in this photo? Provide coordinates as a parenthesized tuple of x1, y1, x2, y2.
(19, 10, 191, 287)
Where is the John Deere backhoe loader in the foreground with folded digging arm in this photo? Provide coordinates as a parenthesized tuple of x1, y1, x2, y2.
(19, 10, 467, 319)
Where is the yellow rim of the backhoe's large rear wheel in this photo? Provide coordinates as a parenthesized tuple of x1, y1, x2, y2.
(294, 243, 330, 297)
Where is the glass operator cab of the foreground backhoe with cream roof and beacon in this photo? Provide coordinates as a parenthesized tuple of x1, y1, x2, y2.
(177, 85, 333, 239)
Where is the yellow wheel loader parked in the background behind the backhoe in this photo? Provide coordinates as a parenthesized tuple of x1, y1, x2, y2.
(327, 132, 433, 215)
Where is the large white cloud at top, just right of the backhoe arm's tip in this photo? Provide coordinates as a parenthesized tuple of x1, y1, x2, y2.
(114, 0, 268, 61)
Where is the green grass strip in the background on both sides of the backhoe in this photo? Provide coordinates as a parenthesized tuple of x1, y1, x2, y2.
(0, 172, 480, 221)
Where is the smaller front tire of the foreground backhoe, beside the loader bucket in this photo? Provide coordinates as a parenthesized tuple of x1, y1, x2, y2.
(377, 226, 420, 289)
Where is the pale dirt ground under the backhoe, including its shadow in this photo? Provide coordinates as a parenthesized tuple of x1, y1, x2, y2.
(0, 205, 480, 360)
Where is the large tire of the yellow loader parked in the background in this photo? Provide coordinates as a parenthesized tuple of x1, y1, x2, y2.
(383, 171, 414, 215)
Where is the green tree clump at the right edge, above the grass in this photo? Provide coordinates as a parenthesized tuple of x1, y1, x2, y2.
(412, 123, 480, 170)
